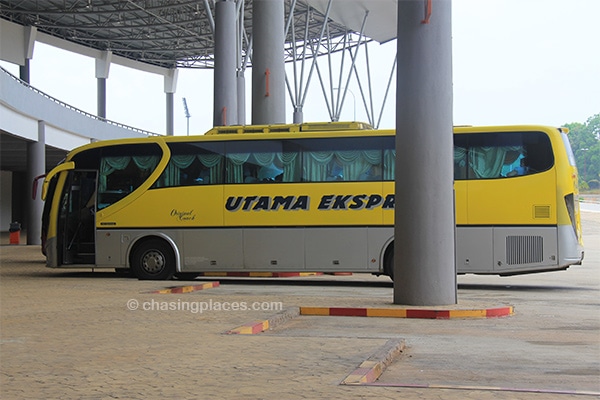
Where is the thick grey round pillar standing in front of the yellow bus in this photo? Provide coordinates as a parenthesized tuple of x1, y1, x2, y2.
(394, 0, 456, 306)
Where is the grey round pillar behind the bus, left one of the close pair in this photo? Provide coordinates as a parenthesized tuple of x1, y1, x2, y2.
(213, 0, 238, 126)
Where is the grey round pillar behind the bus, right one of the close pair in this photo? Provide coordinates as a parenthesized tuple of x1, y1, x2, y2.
(252, 0, 286, 125)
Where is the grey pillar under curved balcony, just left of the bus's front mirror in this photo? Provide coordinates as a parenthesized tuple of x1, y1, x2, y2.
(25, 121, 46, 244)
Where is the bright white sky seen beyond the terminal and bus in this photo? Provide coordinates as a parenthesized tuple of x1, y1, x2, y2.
(0, 0, 600, 135)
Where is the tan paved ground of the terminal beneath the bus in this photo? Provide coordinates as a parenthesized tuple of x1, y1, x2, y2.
(0, 212, 600, 399)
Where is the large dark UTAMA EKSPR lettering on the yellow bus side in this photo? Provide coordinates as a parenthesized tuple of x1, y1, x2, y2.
(225, 194, 394, 211)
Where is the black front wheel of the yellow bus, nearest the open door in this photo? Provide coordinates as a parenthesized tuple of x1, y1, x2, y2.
(131, 238, 175, 281)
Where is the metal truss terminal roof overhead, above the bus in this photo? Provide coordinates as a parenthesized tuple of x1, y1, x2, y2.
(0, 0, 397, 68)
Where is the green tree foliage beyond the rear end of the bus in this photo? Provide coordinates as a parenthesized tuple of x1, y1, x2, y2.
(565, 114, 600, 184)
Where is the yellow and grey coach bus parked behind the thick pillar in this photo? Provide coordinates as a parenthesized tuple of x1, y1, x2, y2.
(42, 123, 583, 279)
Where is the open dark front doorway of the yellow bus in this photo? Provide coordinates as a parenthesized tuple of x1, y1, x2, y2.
(58, 170, 97, 265)
